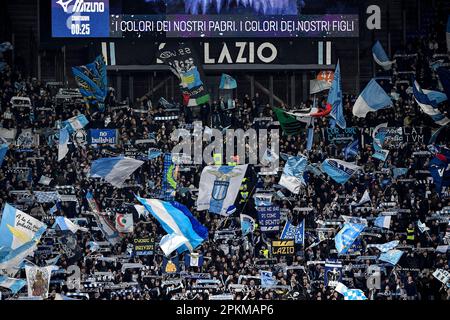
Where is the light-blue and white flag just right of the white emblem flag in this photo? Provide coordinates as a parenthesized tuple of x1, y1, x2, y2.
(279, 156, 308, 194)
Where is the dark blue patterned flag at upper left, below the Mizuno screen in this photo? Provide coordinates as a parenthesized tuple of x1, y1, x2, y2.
(72, 56, 108, 110)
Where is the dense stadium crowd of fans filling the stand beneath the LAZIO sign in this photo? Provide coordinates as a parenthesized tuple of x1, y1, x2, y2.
(0, 12, 450, 300)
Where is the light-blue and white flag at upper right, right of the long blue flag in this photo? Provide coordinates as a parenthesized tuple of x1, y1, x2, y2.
(353, 79, 392, 118)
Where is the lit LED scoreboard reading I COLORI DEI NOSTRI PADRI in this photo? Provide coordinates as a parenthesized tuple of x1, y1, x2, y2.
(51, 0, 359, 38)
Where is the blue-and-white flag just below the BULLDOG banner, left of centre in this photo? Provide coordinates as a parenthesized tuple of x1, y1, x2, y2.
(91, 156, 144, 188)
